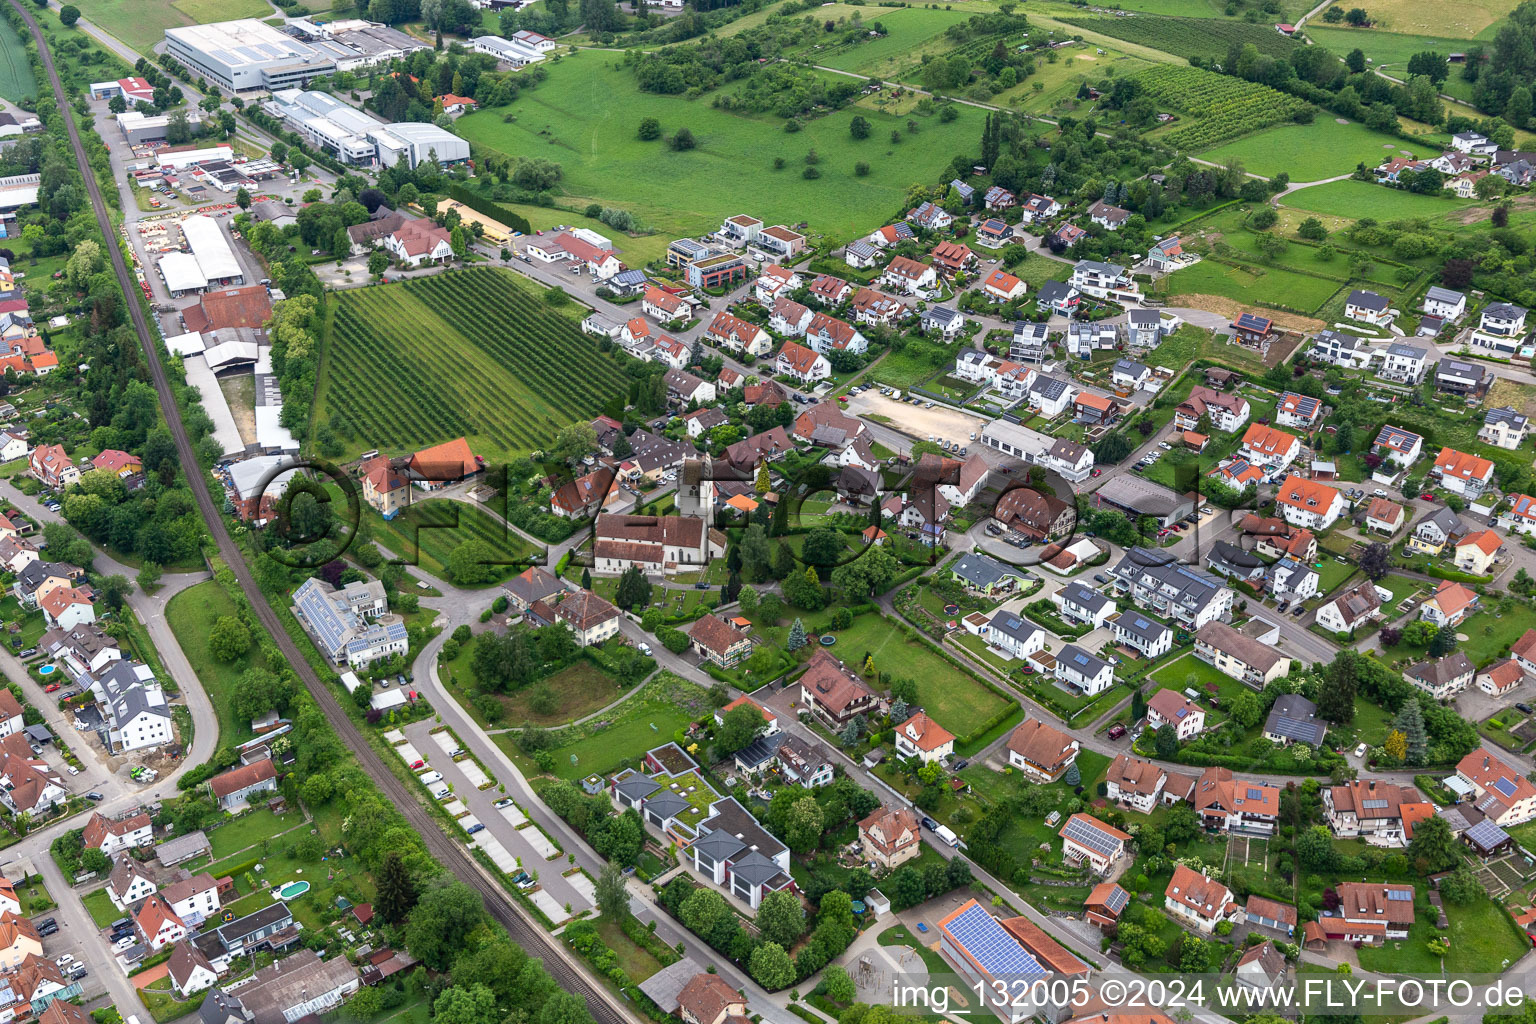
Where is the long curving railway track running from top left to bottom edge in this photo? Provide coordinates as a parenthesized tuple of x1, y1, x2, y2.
(11, 0, 639, 1024)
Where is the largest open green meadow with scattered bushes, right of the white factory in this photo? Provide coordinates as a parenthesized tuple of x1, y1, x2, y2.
(458, 52, 983, 247)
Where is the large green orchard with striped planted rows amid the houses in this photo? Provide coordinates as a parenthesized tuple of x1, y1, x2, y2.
(315, 269, 625, 459)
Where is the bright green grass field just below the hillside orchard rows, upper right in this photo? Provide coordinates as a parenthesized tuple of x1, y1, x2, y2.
(1200, 115, 1439, 181)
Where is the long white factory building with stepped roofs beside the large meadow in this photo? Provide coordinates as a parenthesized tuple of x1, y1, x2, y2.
(263, 89, 470, 167)
